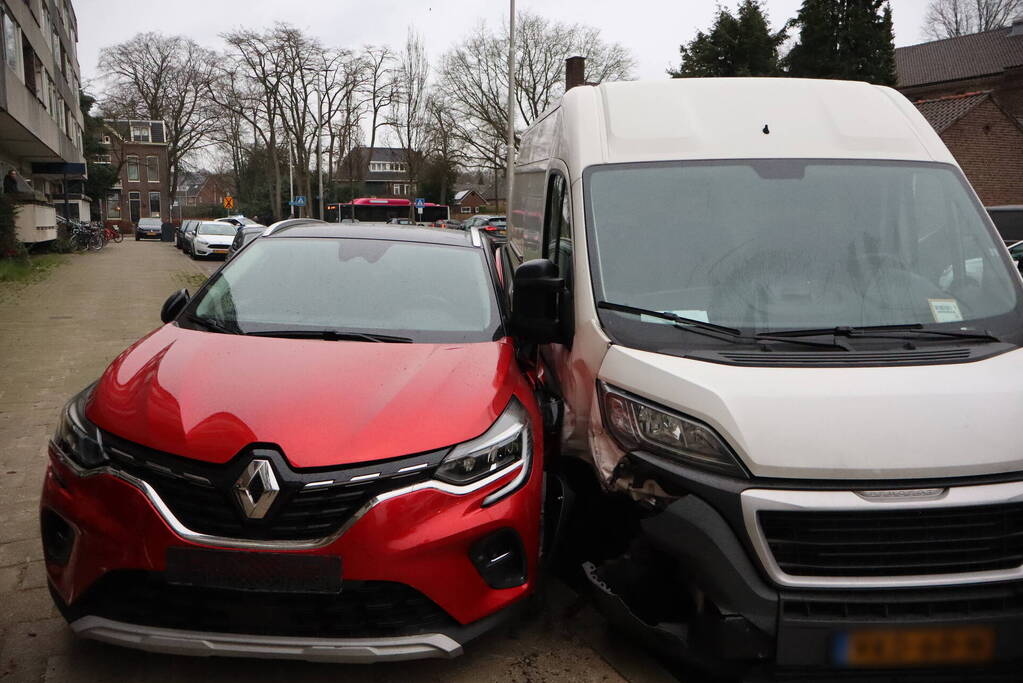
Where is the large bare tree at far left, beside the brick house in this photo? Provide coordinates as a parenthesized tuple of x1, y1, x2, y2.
(99, 33, 219, 208)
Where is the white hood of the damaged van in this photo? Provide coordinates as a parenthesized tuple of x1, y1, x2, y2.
(599, 346, 1023, 480)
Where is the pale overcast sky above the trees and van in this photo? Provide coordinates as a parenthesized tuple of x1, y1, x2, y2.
(74, 0, 928, 89)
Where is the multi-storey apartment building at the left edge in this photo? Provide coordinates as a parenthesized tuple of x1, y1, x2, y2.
(0, 0, 90, 242)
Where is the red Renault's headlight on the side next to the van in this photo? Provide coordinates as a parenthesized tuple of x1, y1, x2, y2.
(434, 398, 533, 507)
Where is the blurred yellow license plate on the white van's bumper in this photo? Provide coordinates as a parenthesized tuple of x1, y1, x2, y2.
(835, 626, 994, 669)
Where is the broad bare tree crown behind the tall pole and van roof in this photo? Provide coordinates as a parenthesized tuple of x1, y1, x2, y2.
(441, 11, 635, 168)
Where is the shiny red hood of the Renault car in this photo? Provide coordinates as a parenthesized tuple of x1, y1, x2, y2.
(86, 324, 519, 467)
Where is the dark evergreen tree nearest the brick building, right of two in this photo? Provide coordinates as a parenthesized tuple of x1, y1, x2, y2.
(786, 0, 895, 86)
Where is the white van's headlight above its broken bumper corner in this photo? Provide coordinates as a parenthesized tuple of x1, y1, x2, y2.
(598, 382, 746, 477)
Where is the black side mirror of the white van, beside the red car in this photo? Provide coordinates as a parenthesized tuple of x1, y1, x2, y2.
(510, 259, 565, 344)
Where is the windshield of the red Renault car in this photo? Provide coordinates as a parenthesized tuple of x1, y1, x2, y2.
(192, 239, 500, 344)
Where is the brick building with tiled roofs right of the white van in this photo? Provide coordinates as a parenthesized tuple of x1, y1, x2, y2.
(895, 16, 1023, 206)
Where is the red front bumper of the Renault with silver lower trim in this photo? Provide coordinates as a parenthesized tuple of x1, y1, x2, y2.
(41, 437, 542, 662)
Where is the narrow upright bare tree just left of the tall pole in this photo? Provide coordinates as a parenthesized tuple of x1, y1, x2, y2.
(387, 29, 430, 213)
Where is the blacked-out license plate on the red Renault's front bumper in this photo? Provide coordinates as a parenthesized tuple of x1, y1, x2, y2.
(166, 548, 341, 594)
